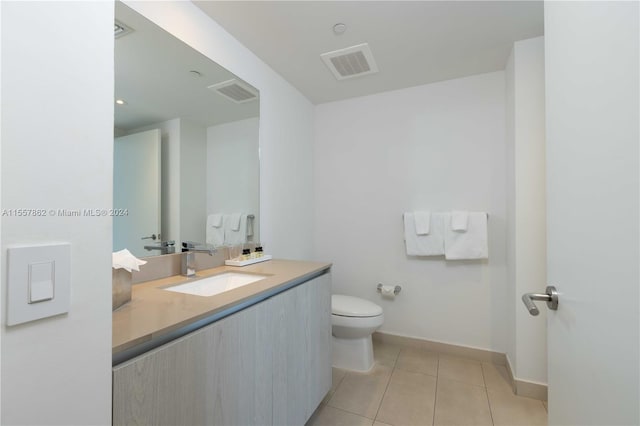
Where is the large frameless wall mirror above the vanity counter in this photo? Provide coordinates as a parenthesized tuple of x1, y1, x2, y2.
(113, 2, 260, 257)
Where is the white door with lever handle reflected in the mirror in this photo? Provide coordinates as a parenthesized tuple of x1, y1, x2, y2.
(113, 129, 160, 257)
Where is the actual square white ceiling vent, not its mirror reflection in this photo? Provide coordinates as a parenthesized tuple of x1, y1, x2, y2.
(320, 43, 378, 80)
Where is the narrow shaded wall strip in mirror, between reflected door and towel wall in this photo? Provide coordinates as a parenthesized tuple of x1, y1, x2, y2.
(180, 119, 207, 243)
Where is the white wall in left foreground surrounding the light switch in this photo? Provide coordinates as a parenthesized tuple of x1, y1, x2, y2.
(0, 2, 114, 425)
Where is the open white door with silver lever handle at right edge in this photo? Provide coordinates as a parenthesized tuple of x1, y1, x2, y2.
(538, 1, 640, 425)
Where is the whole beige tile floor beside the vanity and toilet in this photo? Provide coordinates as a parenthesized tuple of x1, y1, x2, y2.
(307, 342, 547, 426)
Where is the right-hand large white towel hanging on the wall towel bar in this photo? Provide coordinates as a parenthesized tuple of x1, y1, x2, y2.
(444, 212, 489, 260)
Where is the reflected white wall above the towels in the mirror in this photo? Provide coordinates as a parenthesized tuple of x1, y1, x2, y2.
(207, 117, 262, 243)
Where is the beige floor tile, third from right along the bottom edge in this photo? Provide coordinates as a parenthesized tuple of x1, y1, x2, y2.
(376, 369, 436, 425)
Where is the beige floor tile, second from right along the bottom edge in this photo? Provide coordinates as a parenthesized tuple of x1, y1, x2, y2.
(434, 377, 493, 426)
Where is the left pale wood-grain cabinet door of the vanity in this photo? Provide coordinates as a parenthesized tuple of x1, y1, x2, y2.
(113, 301, 272, 425)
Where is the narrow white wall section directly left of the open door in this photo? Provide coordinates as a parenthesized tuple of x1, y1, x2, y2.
(507, 37, 547, 383)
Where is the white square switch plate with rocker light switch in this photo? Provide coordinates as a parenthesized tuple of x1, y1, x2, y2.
(7, 243, 71, 325)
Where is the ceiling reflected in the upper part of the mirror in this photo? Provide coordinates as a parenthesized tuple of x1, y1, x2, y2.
(114, 2, 259, 130)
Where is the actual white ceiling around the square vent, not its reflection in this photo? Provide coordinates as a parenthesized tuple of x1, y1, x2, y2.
(194, 0, 543, 104)
